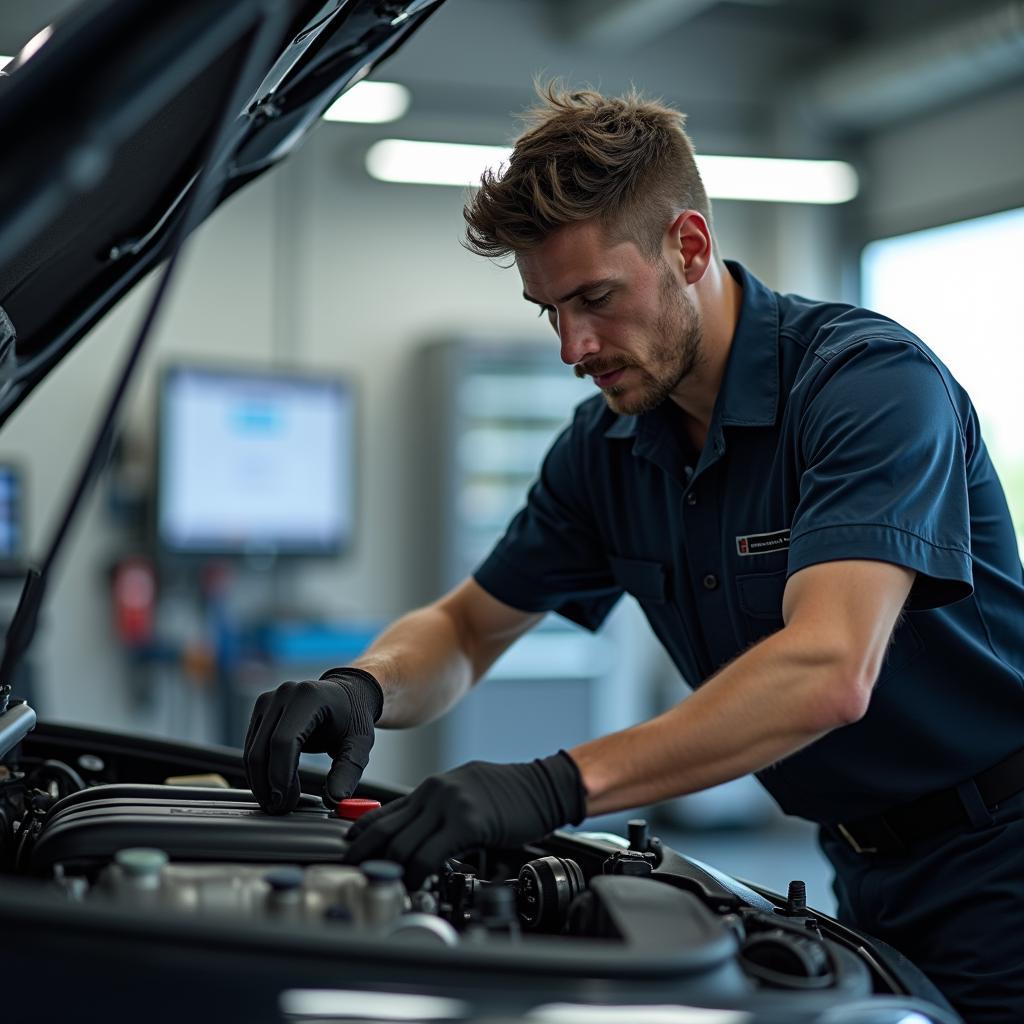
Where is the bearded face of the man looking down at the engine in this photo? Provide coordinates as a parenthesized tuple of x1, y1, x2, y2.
(517, 221, 701, 415)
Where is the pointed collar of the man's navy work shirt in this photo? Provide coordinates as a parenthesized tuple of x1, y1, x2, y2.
(604, 260, 778, 438)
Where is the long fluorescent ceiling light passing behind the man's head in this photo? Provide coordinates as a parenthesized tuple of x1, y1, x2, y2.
(367, 138, 858, 203)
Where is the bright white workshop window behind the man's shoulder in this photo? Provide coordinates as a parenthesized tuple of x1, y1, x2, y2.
(860, 210, 1024, 552)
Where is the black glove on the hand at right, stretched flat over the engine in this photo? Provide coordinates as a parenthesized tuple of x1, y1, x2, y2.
(345, 751, 587, 888)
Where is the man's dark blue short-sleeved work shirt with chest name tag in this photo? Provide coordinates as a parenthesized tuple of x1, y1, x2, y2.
(474, 262, 1024, 823)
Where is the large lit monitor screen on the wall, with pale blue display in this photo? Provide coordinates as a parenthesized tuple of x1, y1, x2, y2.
(157, 367, 355, 555)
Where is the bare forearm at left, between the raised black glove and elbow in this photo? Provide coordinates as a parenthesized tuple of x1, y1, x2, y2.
(352, 605, 474, 729)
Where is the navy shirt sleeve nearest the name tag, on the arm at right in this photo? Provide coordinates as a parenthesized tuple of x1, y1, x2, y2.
(788, 338, 973, 609)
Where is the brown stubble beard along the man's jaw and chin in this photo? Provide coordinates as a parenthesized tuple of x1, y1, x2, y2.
(603, 266, 703, 416)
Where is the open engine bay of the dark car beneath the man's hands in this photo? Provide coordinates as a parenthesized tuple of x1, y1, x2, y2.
(0, 726, 955, 1021)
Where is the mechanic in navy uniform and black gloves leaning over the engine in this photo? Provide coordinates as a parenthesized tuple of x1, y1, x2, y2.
(245, 84, 1024, 1022)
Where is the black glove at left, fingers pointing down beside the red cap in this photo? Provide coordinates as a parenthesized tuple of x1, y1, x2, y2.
(243, 669, 384, 814)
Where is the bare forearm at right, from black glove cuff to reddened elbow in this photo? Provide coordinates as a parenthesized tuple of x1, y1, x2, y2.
(569, 631, 856, 814)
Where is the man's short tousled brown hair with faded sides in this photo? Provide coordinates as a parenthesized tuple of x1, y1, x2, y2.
(463, 79, 712, 260)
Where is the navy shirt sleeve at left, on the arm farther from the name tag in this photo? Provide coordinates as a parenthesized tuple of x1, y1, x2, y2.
(473, 407, 623, 630)
